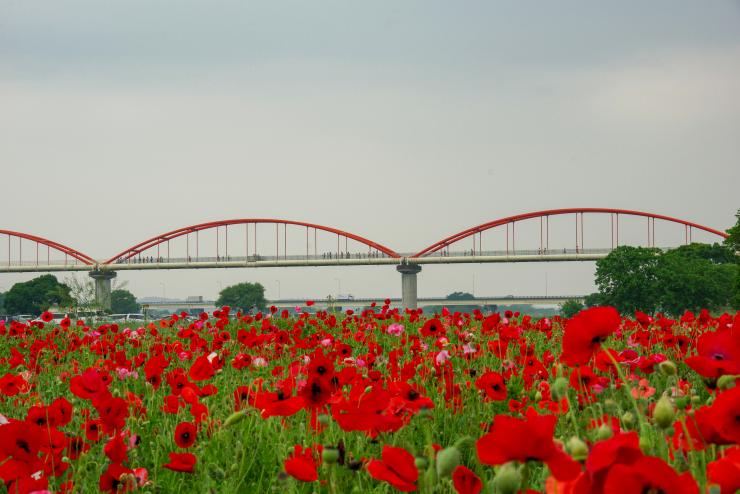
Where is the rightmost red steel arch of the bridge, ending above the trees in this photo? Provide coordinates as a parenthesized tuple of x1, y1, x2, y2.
(412, 208, 728, 257)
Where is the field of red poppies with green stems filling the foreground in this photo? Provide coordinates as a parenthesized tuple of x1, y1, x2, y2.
(0, 301, 740, 494)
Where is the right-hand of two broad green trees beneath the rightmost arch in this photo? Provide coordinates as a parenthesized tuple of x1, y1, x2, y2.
(657, 244, 738, 316)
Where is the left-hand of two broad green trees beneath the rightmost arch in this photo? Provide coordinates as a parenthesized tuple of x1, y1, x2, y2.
(596, 246, 660, 314)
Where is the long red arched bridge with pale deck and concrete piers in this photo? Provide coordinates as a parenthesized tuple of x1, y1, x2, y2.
(0, 208, 727, 308)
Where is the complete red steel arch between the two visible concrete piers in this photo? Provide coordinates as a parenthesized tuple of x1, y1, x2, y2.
(103, 218, 401, 265)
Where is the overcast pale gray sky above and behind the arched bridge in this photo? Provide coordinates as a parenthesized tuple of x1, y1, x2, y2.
(0, 0, 740, 297)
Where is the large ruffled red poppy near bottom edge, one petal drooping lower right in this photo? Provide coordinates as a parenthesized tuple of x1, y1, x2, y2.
(476, 408, 581, 480)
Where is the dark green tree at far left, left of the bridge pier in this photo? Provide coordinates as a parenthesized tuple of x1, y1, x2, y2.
(4, 274, 73, 315)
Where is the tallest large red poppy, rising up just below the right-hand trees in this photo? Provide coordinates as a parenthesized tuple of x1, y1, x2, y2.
(561, 307, 621, 367)
